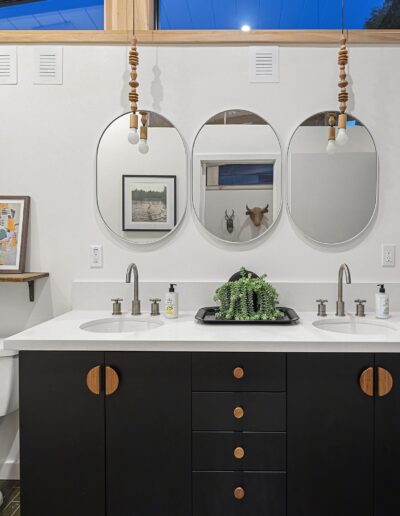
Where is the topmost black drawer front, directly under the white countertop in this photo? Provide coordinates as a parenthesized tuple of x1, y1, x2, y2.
(192, 352, 286, 392)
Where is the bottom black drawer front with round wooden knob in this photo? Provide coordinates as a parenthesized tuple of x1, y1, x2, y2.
(193, 472, 286, 516)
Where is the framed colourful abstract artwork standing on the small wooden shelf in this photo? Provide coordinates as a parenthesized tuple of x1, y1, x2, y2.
(0, 195, 31, 274)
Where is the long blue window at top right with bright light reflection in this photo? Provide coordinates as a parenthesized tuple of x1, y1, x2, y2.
(157, 0, 400, 31)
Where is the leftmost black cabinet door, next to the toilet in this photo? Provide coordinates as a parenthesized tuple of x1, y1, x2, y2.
(19, 351, 105, 516)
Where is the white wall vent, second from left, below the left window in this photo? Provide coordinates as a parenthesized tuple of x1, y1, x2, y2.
(33, 47, 63, 84)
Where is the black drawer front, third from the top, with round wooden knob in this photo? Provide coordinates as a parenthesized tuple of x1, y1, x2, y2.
(192, 432, 286, 471)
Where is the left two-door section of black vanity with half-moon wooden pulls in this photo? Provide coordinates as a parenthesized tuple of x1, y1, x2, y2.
(20, 351, 191, 516)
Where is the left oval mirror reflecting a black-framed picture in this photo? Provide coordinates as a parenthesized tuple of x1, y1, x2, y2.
(96, 111, 187, 244)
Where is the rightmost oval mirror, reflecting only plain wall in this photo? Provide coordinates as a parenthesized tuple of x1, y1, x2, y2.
(288, 112, 378, 244)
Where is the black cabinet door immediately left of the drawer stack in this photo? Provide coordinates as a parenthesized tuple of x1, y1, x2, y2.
(106, 352, 191, 516)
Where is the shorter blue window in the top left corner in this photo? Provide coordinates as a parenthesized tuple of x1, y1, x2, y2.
(0, 0, 104, 30)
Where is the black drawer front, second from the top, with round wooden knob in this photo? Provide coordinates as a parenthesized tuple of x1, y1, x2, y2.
(192, 392, 286, 432)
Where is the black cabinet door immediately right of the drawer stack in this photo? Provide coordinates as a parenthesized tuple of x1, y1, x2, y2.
(287, 353, 376, 516)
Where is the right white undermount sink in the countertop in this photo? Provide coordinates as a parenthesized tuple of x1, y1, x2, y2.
(313, 318, 397, 335)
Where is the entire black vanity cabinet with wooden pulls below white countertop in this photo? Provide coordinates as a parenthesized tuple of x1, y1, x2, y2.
(20, 351, 400, 516)
